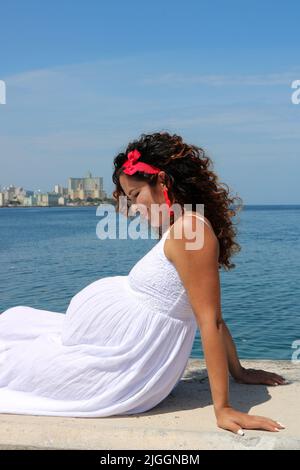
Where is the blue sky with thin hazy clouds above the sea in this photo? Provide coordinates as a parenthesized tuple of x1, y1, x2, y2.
(0, 0, 300, 204)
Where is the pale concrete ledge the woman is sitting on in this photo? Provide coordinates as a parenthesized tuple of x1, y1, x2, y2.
(0, 359, 300, 450)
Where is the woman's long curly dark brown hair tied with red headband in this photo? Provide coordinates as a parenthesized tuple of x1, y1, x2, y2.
(112, 132, 243, 271)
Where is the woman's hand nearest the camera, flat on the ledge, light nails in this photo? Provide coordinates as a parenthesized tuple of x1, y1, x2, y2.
(216, 406, 285, 435)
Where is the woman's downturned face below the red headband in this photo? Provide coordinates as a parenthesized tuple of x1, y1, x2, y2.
(120, 171, 171, 227)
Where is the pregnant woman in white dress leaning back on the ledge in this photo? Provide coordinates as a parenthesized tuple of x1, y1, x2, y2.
(0, 132, 285, 434)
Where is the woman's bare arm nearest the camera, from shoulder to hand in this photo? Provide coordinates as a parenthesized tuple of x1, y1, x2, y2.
(166, 216, 282, 432)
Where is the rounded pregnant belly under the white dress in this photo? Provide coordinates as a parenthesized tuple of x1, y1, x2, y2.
(62, 276, 147, 347)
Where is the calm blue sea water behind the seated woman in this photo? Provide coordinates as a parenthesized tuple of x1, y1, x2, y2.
(0, 205, 300, 360)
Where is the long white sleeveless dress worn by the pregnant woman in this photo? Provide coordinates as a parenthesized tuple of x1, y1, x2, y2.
(0, 212, 209, 417)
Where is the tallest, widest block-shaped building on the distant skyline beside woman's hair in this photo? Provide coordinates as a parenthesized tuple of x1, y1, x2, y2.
(68, 172, 106, 200)
